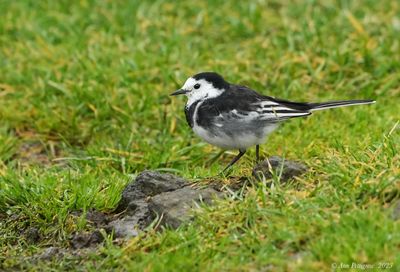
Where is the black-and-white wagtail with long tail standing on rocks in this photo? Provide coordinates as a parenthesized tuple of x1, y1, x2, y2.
(171, 72, 375, 172)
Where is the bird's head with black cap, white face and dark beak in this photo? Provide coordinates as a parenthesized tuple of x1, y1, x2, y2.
(171, 72, 229, 104)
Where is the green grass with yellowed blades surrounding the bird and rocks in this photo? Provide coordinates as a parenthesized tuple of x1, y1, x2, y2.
(0, 0, 400, 271)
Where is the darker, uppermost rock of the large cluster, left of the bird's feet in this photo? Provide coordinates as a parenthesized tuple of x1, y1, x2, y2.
(116, 171, 188, 212)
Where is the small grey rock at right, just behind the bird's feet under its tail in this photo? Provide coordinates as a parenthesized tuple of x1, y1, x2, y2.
(253, 156, 308, 182)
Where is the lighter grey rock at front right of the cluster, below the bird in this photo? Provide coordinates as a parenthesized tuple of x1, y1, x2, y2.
(149, 187, 220, 228)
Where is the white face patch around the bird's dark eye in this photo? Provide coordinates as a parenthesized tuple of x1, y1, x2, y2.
(182, 77, 224, 107)
